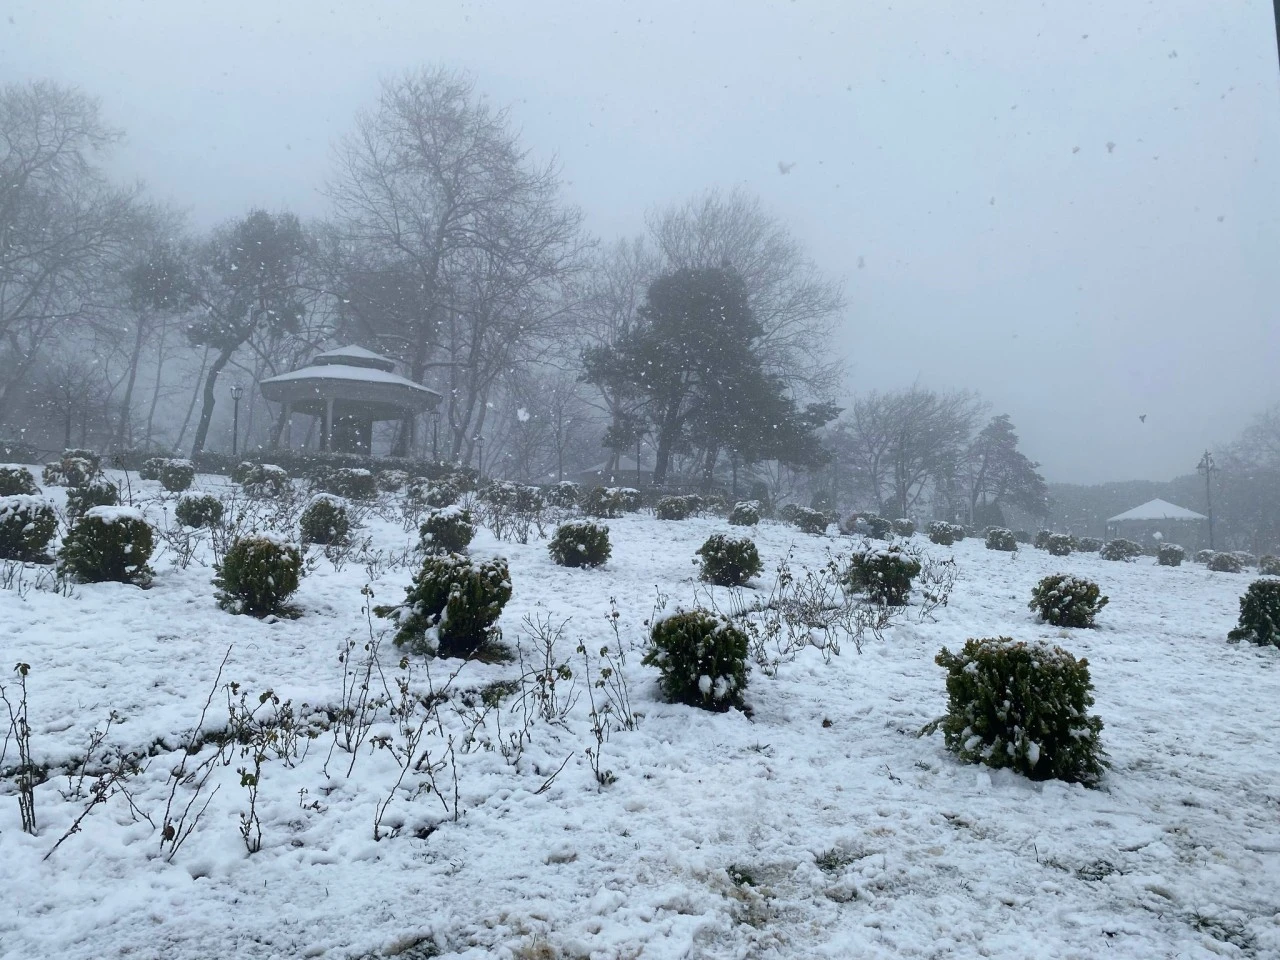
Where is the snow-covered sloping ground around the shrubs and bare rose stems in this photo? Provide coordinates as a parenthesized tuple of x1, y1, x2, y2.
(0, 477, 1280, 960)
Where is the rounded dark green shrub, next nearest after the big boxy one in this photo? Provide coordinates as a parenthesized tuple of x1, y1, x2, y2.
(644, 611, 748, 710)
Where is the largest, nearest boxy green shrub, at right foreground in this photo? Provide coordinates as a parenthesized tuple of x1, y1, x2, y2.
(936, 636, 1106, 785)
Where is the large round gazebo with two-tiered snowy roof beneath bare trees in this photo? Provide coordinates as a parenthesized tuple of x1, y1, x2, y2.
(259, 346, 440, 454)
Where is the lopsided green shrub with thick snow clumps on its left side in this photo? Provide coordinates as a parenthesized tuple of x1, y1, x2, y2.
(374, 553, 511, 657)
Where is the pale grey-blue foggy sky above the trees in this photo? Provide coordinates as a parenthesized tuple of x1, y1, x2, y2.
(0, 0, 1280, 483)
